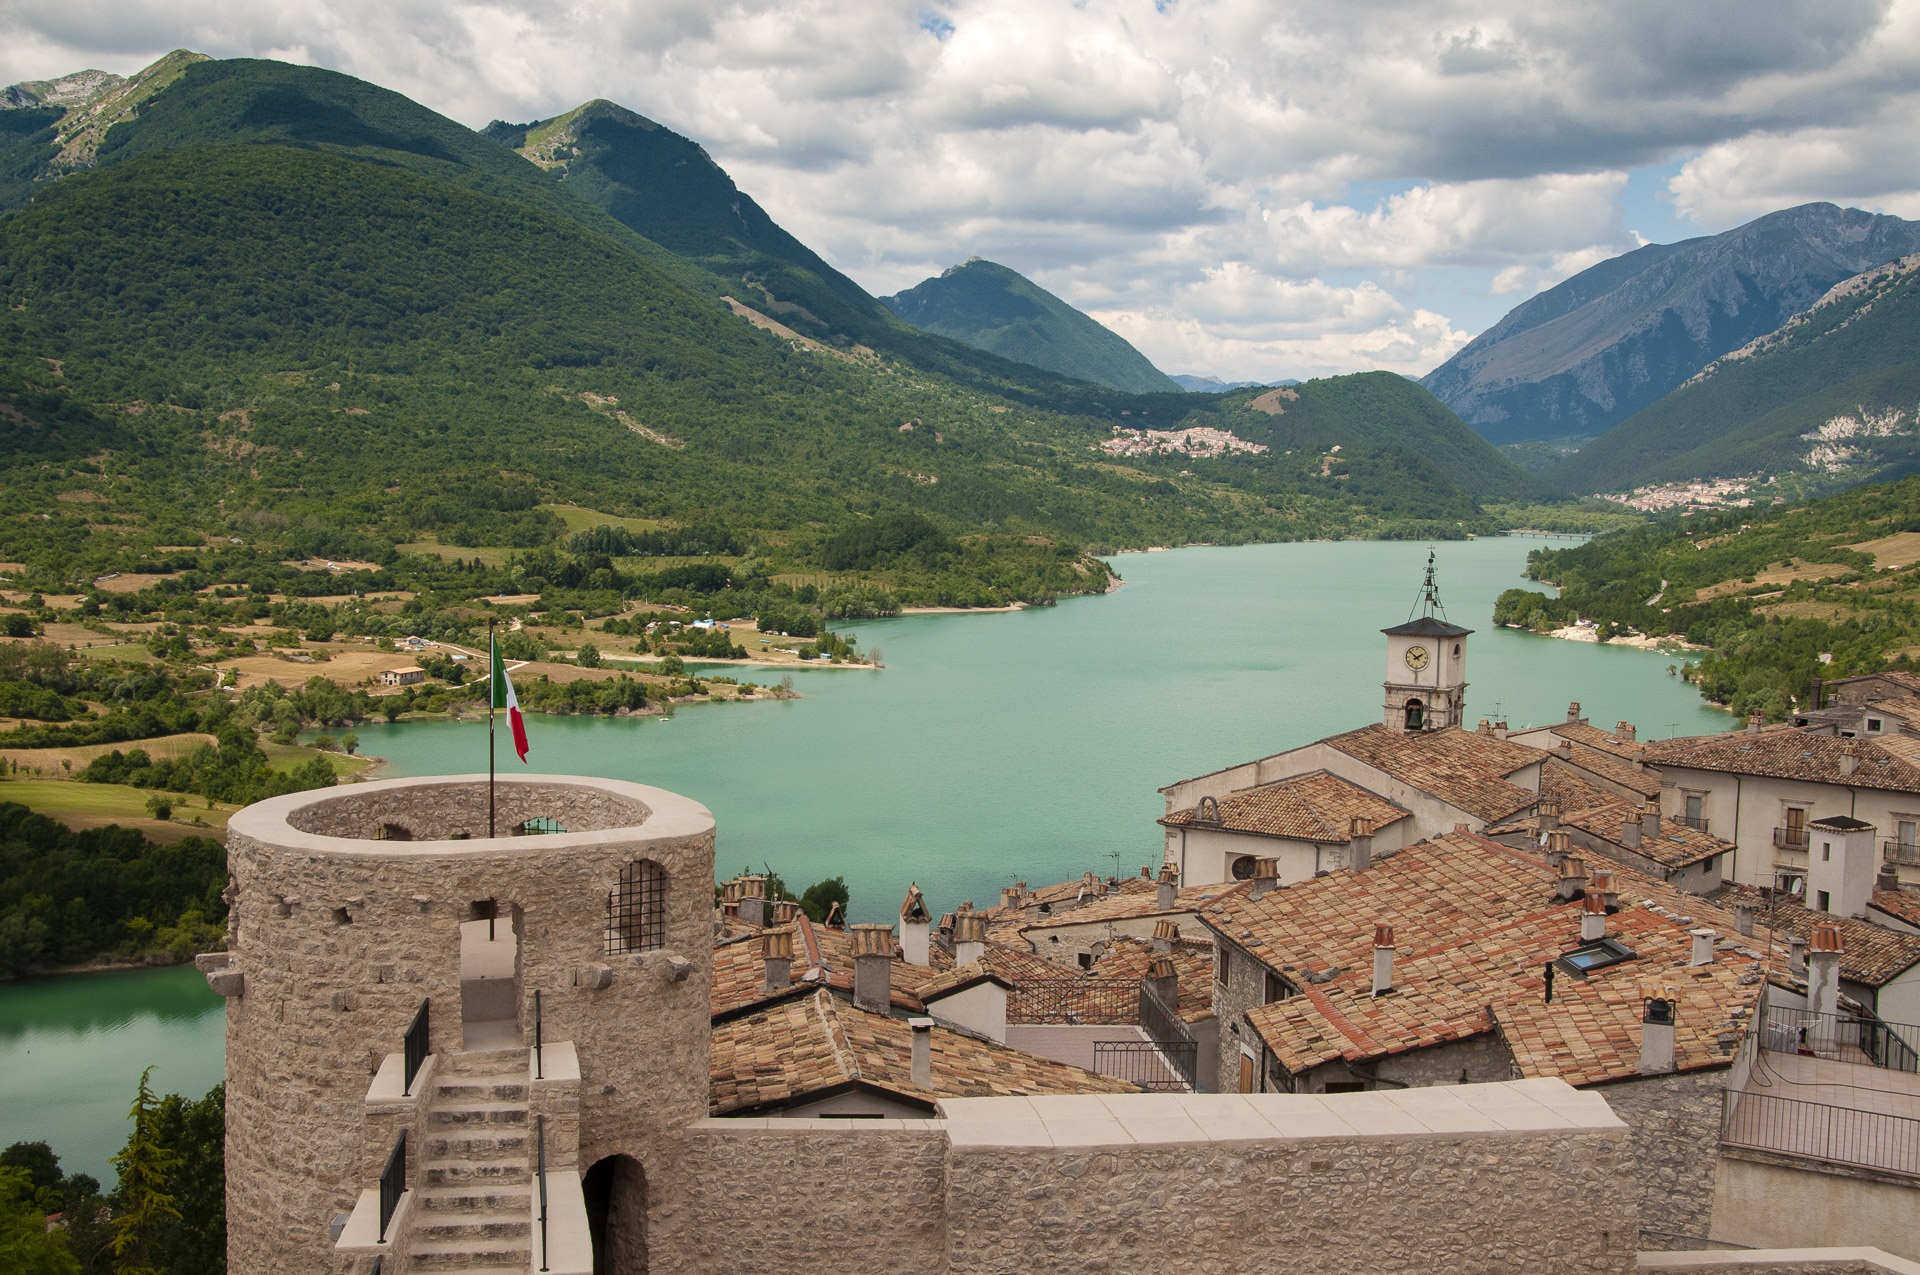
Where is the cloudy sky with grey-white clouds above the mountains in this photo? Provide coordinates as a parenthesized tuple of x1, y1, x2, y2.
(0, 0, 1920, 380)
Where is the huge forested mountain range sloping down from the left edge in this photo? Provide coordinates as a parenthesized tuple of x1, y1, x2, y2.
(0, 56, 1559, 595)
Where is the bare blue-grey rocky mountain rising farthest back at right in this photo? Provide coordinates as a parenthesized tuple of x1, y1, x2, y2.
(1421, 204, 1920, 444)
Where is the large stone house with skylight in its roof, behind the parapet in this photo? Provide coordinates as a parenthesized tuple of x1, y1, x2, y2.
(1202, 830, 1764, 1235)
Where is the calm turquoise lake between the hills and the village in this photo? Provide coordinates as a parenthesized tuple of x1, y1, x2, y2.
(0, 538, 1732, 1181)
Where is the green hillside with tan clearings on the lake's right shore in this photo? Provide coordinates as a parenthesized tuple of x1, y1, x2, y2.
(1494, 478, 1920, 720)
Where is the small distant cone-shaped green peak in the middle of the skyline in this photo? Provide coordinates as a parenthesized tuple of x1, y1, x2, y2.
(881, 257, 1181, 394)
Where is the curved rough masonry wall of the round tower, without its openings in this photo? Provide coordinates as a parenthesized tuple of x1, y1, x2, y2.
(223, 778, 712, 1271)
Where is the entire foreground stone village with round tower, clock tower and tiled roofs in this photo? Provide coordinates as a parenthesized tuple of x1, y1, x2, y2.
(200, 565, 1920, 1275)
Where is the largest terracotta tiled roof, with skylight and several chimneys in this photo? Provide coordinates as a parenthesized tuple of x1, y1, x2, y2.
(1202, 833, 1761, 1083)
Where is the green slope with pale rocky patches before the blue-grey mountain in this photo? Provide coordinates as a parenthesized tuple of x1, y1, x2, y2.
(1549, 253, 1920, 492)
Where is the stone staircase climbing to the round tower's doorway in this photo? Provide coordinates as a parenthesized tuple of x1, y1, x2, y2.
(407, 1048, 534, 1275)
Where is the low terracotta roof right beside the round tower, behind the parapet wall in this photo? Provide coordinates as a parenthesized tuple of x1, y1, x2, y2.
(710, 993, 1139, 1116)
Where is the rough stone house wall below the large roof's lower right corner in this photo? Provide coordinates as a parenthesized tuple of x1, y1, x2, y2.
(1599, 1068, 1728, 1248)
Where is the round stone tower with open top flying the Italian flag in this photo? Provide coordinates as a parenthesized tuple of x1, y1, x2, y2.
(217, 776, 714, 1271)
